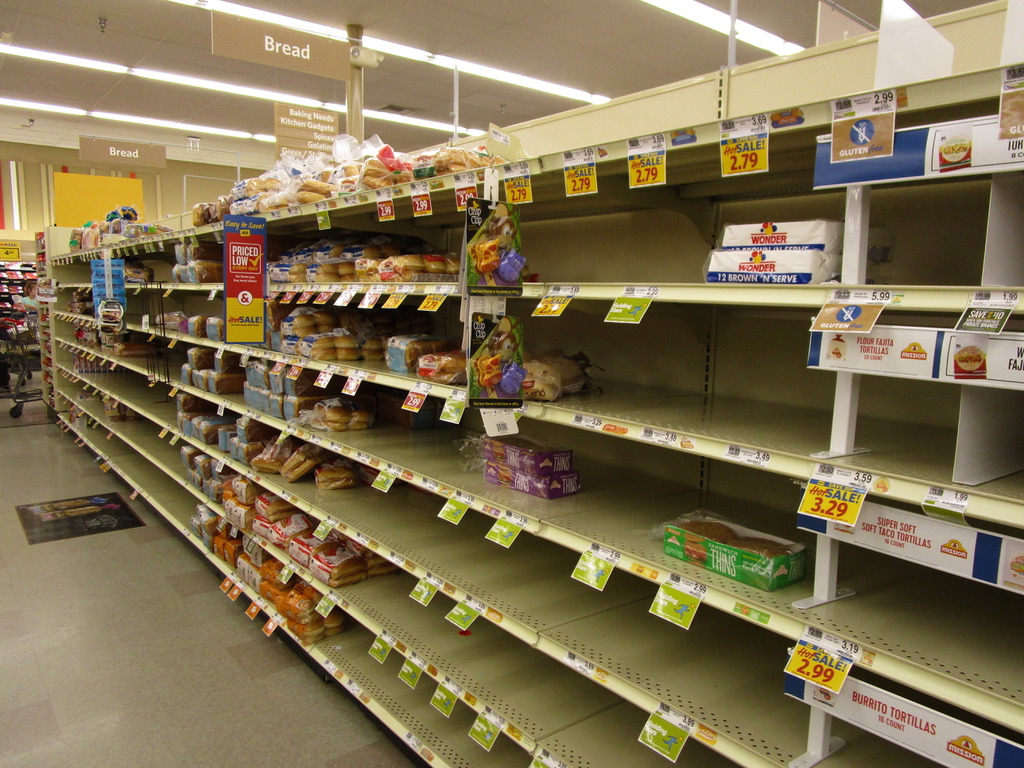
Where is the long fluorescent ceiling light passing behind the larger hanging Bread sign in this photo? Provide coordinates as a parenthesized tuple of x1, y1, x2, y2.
(160, 0, 606, 104)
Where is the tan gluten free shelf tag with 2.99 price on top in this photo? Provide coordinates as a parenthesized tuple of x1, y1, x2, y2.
(831, 88, 896, 163)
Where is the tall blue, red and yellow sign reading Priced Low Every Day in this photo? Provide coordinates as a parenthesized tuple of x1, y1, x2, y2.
(224, 210, 266, 344)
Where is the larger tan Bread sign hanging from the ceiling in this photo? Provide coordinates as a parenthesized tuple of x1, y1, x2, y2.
(210, 13, 348, 80)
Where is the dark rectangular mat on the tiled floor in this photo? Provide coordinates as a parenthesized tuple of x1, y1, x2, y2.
(17, 494, 145, 544)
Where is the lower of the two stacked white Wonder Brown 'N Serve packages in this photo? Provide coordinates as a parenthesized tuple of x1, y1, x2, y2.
(707, 248, 842, 285)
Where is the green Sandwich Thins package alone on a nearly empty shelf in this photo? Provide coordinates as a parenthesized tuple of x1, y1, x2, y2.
(663, 511, 806, 592)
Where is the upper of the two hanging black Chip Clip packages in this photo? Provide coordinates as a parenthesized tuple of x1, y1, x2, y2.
(466, 198, 526, 296)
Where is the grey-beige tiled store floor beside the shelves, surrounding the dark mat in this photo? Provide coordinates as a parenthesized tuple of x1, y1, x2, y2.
(0, 425, 415, 768)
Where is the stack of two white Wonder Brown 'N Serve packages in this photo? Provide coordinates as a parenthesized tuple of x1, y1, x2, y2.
(707, 219, 843, 285)
